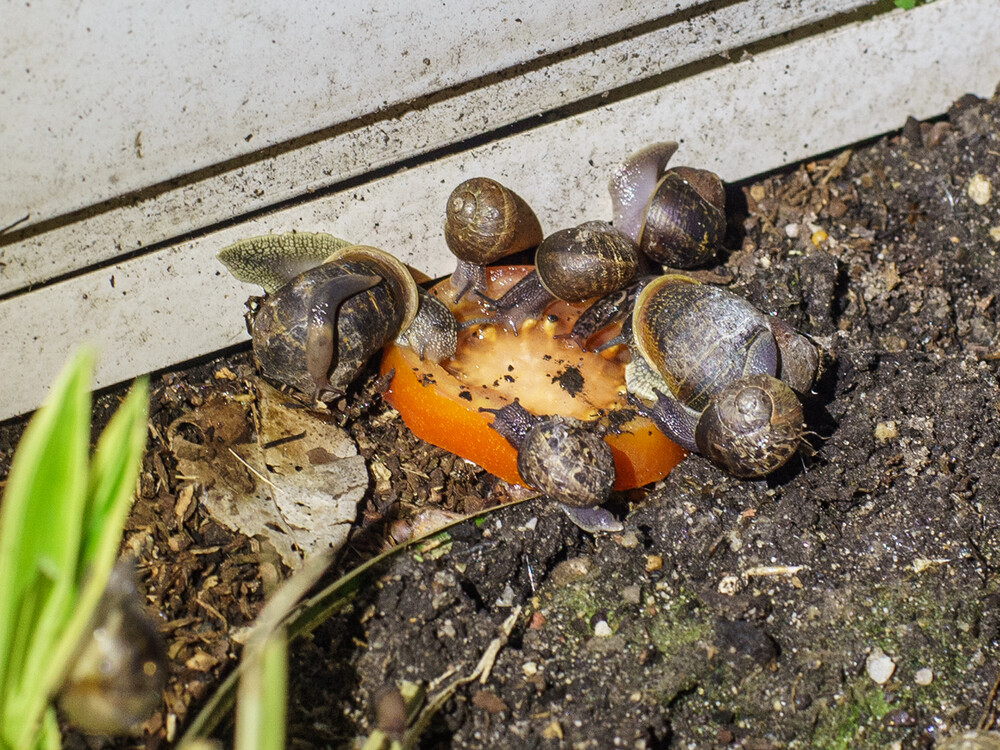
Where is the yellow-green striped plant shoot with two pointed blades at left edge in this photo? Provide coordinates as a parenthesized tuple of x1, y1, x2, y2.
(0, 349, 149, 750)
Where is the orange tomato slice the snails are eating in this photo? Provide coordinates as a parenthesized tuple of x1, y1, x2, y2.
(381, 266, 686, 490)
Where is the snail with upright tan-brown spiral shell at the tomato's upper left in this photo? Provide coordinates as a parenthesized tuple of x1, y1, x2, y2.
(444, 177, 542, 302)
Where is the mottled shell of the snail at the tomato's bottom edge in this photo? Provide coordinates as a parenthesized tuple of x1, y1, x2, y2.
(517, 417, 615, 508)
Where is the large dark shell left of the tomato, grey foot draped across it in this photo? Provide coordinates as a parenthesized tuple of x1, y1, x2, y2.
(250, 245, 419, 398)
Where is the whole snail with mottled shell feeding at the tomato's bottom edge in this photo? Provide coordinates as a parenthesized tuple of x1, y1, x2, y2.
(491, 401, 622, 532)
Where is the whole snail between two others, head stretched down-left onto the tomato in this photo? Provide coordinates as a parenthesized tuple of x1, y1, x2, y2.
(478, 221, 639, 332)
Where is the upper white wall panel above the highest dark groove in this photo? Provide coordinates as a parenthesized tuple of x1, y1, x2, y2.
(0, 0, 696, 232)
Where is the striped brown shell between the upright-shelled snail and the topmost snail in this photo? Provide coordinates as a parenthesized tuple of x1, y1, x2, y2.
(535, 221, 639, 302)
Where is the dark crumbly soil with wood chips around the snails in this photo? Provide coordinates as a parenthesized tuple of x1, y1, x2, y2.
(2, 83, 1000, 750)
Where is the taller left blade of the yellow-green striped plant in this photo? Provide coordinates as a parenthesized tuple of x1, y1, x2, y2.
(0, 350, 93, 747)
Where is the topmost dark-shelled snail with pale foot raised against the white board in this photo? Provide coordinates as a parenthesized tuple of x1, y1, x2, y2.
(608, 141, 726, 268)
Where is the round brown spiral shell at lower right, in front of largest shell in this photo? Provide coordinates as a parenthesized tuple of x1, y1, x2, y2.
(695, 373, 803, 477)
